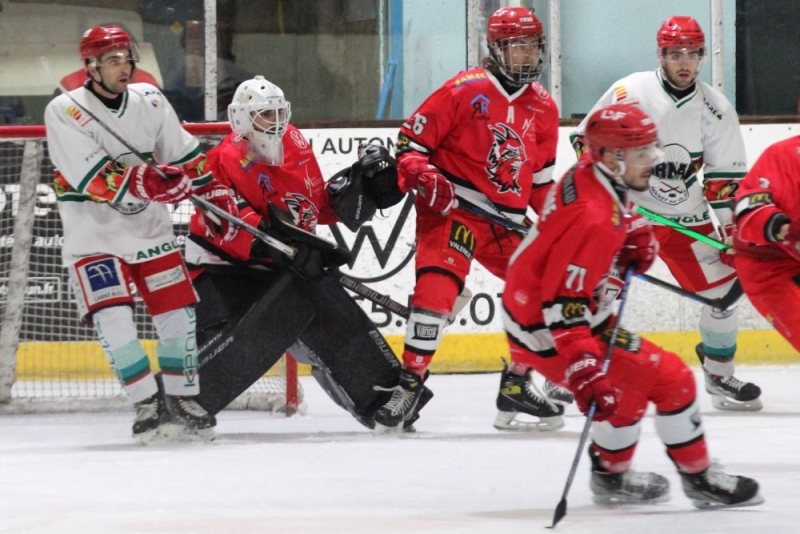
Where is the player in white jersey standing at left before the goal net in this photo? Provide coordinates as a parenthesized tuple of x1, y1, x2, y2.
(45, 26, 237, 439)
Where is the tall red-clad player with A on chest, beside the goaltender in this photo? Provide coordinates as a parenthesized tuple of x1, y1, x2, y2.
(375, 7, 566, 436)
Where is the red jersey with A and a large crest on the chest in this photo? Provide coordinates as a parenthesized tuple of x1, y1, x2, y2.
(398, 68, 558, 222)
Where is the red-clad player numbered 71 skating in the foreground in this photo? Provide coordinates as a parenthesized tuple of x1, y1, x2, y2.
(503, 104, 763, 507)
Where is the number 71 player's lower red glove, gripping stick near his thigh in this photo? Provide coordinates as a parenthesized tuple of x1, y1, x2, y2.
(566, 353, 617, 421)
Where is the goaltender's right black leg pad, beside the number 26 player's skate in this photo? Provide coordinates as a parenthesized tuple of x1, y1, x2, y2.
(296, 278, 400, 420)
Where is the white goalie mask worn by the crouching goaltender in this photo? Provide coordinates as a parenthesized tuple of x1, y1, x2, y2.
(228, 76, 292, 165)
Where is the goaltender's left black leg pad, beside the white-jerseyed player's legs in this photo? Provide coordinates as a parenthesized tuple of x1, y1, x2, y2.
(195, 269, 314, 414)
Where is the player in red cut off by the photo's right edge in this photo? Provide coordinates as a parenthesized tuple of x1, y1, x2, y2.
(733, 136, 800, 351)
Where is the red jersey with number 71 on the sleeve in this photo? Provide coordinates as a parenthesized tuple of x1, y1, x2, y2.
(503, 160, 629, 359)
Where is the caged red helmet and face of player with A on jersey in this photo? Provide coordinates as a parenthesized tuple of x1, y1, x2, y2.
(486, 7, 547, 85)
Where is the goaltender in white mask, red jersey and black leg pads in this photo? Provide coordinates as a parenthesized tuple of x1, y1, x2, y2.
(186, 76, 424, 431)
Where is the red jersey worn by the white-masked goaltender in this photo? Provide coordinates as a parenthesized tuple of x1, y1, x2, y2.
(187, 124, 338, 264)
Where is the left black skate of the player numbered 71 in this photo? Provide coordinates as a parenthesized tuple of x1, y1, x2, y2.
(589, 447, 670, 504)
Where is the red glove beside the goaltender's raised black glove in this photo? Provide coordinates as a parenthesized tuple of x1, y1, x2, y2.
(397, 154, 456, 215)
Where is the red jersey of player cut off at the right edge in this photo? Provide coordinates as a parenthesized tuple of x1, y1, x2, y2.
(736, 136, 800, 247)
